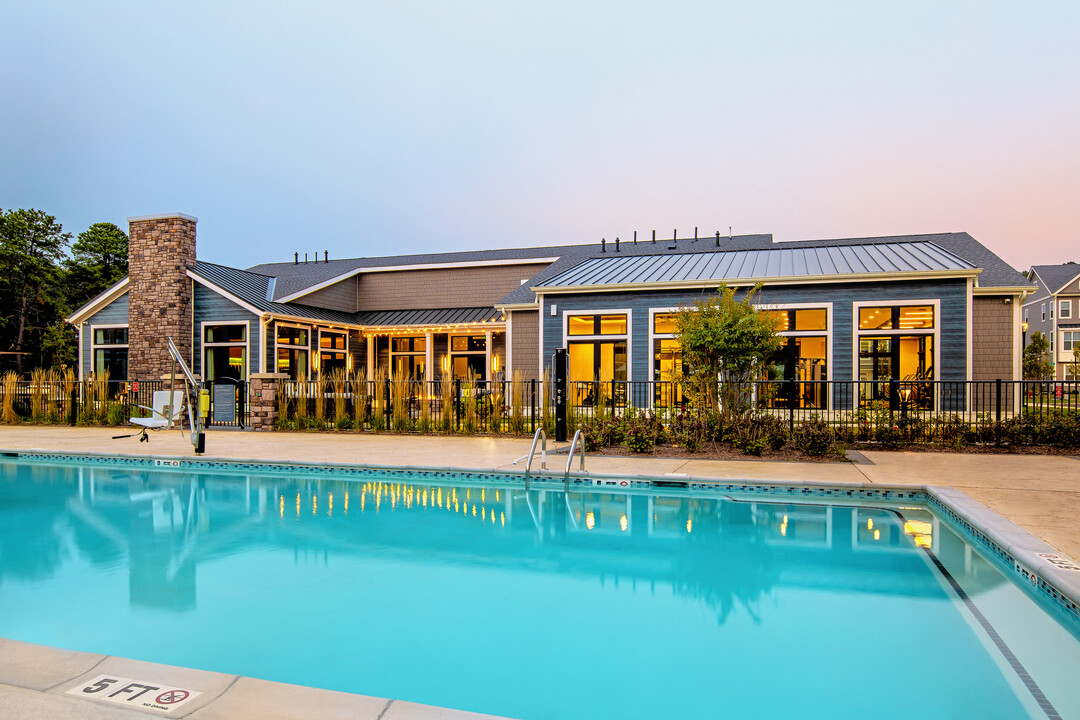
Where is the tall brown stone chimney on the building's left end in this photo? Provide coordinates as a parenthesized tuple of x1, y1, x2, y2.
(127, 213, 198, 380)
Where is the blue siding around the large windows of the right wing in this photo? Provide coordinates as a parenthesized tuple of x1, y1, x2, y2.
(540, 280, 968, 380)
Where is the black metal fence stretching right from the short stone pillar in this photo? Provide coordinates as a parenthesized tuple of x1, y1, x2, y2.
(279, 380, 1080, 439)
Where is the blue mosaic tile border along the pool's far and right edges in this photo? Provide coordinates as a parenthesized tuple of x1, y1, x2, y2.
(0, 449, 1080, 625)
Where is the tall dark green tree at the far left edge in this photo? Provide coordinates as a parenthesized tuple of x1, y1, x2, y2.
(0, 209, 71, 373)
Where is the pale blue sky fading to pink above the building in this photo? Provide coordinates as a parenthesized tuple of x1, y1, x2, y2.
(0, 0, 1080, 270)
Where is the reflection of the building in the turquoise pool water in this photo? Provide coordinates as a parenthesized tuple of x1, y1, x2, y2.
(50, 470, 1001, 622)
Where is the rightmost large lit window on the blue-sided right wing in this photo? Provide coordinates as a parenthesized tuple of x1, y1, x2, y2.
(858, 304, 937, 408)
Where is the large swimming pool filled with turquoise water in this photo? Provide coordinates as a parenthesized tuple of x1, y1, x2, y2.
(0, 458, 1080, 720)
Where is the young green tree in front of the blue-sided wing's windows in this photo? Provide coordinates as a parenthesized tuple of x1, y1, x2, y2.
(675, 285, 782, 418)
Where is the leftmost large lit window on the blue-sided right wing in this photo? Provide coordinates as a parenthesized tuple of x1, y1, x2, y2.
(566, 312, 629, 405)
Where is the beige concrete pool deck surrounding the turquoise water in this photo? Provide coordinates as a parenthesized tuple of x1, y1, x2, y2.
(0, 425, 1080, 720)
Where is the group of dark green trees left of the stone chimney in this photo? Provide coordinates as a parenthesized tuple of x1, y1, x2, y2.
(0, 208, 127, 376)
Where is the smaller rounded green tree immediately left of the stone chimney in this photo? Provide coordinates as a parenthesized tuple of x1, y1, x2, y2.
(64, 222, 127, 311)
